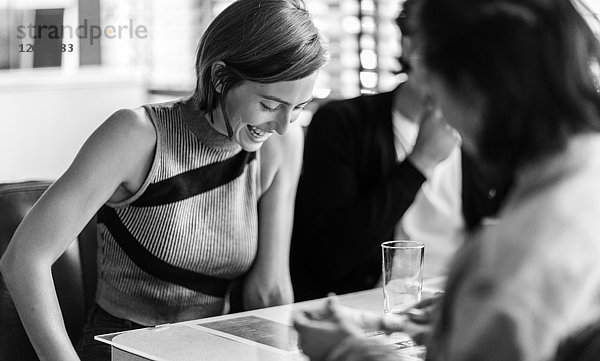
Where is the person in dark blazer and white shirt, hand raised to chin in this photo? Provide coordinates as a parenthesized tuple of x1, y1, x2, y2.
(290, 0, 508, 301)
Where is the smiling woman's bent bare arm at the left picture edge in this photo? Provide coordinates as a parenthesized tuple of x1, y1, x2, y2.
(0, 110, 155, 361)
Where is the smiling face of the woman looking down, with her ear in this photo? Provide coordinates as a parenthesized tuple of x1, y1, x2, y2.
(215, 72, 317, 152)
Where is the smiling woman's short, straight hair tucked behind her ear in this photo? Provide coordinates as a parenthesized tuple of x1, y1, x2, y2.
(194, 0, 326, 134)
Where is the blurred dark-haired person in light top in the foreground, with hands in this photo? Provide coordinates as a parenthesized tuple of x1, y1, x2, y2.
(295, 0, 600, 361)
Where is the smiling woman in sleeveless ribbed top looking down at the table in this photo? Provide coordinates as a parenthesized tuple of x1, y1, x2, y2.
(0, 0, 326, 360)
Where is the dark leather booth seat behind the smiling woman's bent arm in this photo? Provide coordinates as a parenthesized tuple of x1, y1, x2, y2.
(0, 181, 97, 361)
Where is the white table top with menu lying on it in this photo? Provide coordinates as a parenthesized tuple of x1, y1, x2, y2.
(96, 280, 446, 361)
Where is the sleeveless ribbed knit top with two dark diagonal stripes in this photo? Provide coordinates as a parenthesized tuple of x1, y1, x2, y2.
(96, 100, 261, 325)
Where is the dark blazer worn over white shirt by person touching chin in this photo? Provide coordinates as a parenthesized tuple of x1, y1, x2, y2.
(290, 92, 509, 301)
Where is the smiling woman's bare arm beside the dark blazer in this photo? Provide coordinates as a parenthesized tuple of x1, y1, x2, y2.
(244, 124, 304, 309)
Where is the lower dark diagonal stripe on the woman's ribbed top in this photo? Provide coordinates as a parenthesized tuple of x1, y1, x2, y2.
(98, 206, 231, 297)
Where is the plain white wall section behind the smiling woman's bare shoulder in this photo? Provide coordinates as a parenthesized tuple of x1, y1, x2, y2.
(0, 68, 148, 182)
